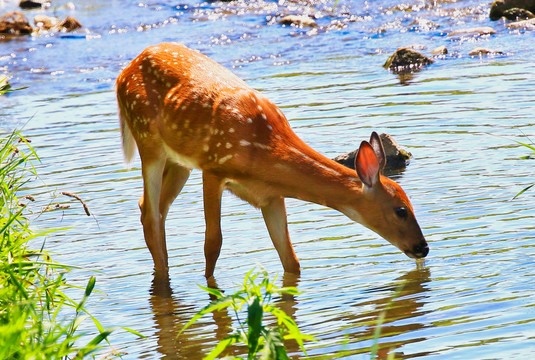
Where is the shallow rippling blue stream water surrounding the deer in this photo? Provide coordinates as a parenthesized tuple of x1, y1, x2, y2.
(0, 0, 535, 359)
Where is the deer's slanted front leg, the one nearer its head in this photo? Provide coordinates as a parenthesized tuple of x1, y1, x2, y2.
(262, 197, 301, 274)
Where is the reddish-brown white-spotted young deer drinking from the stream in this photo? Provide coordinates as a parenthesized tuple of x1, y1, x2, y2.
(116, 43, 429, 278)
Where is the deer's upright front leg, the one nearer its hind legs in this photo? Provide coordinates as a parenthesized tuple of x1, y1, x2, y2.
(202, 171, 223, 279)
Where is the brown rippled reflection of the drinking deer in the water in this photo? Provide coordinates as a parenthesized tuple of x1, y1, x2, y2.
(150, 267, 430, 360)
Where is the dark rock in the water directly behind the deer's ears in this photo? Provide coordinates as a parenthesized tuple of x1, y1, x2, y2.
(333, 133, 412, 175)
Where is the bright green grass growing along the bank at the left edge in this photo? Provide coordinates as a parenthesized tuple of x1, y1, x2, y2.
(0, 132, 139, 360)
